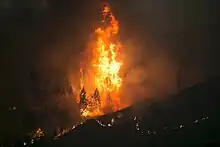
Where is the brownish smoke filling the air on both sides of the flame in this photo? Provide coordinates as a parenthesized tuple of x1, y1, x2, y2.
(1, 0, 220, 138)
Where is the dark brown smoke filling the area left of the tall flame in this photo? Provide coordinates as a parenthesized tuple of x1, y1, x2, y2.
(0, 0, 99, 135)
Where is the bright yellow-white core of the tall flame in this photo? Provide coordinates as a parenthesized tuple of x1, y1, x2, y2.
(93, 38, 122, 92)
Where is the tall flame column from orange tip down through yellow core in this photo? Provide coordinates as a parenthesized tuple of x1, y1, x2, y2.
(93, 6, 122, 92)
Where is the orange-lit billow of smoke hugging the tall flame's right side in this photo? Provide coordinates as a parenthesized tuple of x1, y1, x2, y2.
(118, 40, 178, 102)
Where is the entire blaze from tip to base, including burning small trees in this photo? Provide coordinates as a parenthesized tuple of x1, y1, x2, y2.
(80, 5, 123, 117)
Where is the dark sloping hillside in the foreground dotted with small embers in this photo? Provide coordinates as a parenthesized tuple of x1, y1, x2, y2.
(25, 77, 220, 147)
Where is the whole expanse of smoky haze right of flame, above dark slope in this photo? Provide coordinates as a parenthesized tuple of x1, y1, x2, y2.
(110, 0, 219, 101)
